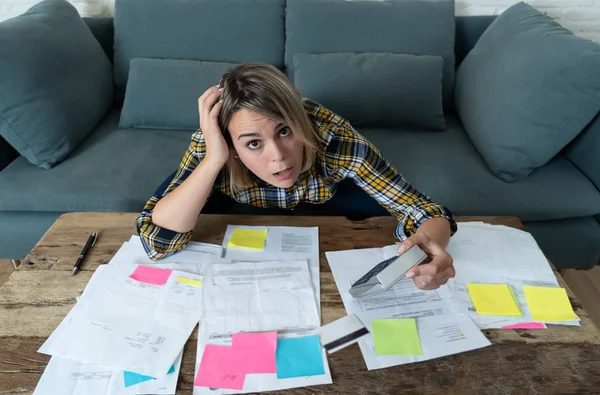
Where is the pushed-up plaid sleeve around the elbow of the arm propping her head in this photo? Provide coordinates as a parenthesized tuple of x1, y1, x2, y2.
(136, 129, 212, 260)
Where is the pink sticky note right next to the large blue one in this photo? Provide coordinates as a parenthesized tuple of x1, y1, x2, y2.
(231, 332, 277, 373)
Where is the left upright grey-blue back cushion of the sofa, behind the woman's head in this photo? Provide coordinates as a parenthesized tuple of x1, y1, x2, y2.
(114, 0, 285, 91)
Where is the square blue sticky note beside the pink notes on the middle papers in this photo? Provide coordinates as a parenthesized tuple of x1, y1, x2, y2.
(275, 335, 325, 379)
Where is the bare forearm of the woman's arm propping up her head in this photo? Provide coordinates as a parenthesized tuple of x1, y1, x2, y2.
(152, 160, 223, 233)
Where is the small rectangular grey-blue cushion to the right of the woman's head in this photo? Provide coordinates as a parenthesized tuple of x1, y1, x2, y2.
(294, 53, 446, 130)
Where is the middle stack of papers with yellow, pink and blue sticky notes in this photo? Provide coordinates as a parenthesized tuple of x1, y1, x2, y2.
(194, 225, 332, 394)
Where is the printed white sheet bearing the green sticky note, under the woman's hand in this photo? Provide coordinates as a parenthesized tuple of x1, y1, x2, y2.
(326, 246, 491, 370)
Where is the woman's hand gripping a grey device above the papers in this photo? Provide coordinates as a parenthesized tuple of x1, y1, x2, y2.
(398, 233, 456, 289)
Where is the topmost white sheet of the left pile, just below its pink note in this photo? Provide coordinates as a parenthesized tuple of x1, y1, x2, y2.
(40, 263, 202, 378)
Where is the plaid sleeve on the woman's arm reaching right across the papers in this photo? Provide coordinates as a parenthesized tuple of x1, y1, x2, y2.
(326, 120, 457, 241)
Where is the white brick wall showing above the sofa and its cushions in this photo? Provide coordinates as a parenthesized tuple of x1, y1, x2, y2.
(0, 0, 600, 42)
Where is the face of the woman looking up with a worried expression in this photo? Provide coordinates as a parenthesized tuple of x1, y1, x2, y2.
(229, 108, 303, 188)
